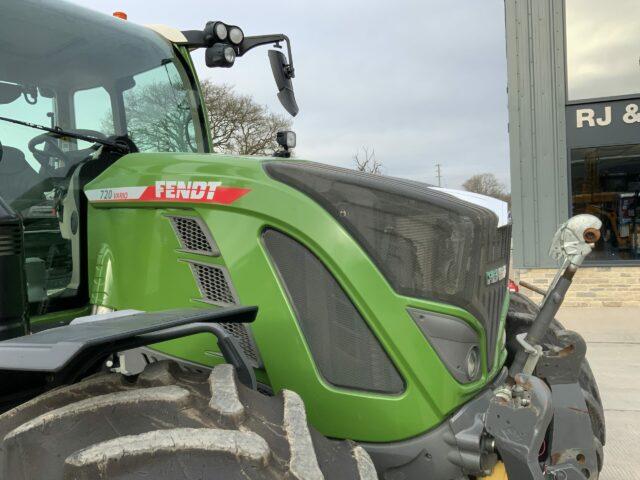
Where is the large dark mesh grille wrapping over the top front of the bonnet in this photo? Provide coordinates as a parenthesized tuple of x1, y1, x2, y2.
(265, 161, 510, 364)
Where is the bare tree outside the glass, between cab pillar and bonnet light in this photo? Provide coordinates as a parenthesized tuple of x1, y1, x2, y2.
(202, 80, 291, 155)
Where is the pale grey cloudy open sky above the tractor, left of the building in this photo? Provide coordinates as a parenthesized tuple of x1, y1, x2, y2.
(70, 0, 509, 188)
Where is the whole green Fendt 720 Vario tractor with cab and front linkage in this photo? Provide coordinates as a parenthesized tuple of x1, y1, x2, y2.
(0, 0, 605, 480)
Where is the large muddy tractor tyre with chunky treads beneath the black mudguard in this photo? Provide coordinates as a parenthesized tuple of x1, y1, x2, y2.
(0, 362, 377, 480)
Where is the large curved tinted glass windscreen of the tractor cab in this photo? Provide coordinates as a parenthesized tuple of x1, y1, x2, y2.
(0, 0, 205, 179)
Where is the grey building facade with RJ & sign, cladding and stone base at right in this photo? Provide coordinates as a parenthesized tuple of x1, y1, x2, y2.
(505, 0, 640, 306)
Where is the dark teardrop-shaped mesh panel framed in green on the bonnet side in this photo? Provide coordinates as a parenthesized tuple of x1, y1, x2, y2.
(263, 230, 404, 393)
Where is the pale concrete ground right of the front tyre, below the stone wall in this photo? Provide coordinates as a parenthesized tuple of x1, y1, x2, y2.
(558, 308, 640, 480)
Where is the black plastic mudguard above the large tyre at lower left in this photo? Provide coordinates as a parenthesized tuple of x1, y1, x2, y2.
(0, 307, 258, 409)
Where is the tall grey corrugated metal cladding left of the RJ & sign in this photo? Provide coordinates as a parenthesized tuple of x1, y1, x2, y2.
(505, 0, 569, 268)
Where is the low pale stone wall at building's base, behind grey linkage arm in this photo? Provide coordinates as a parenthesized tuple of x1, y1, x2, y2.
(511, 266, 640, 307)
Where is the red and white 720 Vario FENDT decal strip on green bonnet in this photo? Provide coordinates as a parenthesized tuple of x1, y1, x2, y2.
(85, 180, 249, 205)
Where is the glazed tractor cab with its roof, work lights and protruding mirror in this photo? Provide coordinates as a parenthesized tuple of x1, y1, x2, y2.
(0, 0, 297, 324)
